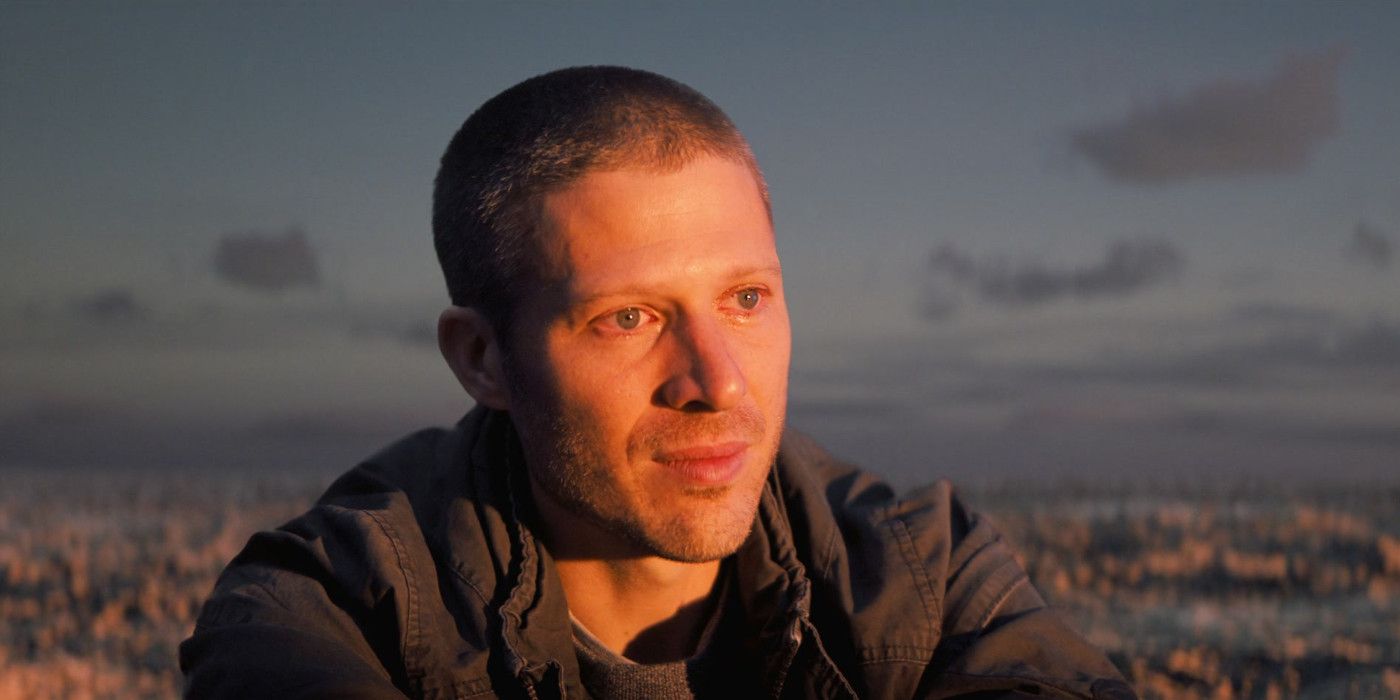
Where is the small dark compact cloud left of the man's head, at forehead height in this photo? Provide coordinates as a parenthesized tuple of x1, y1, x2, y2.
(214, 228, 321, 293)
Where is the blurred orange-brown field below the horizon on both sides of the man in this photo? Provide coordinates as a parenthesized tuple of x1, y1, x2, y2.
(0, 469, 1400, 699)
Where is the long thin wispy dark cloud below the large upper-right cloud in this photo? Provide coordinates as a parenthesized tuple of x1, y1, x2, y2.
(924, 239, 1184, 318)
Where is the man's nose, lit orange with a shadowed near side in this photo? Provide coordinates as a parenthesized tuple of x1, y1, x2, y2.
(658, 319, 749, 412)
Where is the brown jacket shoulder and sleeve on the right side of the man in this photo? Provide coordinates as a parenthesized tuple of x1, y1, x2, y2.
(777, 433, 1131, 697)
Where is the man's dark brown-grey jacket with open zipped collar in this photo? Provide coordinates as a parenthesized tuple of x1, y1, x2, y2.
(179, 409, 1133, 699)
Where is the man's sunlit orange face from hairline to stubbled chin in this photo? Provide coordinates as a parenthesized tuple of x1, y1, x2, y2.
(507, 157, 791, 561)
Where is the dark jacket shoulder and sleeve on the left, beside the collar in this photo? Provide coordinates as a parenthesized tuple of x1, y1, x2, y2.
(181, 411, 498, 697)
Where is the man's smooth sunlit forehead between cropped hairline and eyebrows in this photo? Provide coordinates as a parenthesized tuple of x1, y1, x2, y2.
(539, 157, 778, 300)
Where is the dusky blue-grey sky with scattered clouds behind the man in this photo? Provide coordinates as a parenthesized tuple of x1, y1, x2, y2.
(0, 1, 1400, 486)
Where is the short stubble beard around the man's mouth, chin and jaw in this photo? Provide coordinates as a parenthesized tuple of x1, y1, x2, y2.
(526, 406, 778, 563)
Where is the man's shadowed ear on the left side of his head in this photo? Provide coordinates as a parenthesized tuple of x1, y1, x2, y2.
(438, 307, 511, 410)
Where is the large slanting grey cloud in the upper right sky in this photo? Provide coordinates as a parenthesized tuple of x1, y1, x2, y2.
(1072, 48, 1345, 183)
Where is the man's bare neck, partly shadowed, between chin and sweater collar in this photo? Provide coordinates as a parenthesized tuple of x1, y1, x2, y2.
(531, 480, 720, 664)
